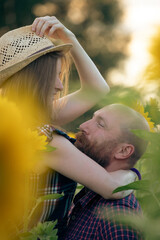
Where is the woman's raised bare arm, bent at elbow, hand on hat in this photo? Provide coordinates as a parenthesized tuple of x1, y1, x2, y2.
(32, 16, 109, 125)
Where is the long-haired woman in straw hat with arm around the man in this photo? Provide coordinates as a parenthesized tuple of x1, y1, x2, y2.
(0, 16, 134, 236)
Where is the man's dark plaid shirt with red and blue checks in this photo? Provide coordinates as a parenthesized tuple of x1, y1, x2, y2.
(61, 188, 142, 240)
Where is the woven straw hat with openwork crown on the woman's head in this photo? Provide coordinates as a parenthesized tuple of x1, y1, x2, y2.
(0, 26, 72, 86)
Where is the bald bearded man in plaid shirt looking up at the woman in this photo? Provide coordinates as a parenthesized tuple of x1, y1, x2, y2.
(62, 104, 149, 240)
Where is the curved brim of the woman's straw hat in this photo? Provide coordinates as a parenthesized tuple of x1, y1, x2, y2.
(0, 44, 72, 87)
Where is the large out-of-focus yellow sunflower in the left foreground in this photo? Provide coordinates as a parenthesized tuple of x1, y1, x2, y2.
(0, 96, 47, 240)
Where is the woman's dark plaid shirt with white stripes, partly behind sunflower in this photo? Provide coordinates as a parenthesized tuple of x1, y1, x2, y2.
(30, 125, 77, 236)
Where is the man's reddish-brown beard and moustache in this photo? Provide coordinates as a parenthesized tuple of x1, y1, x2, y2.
(75, 132, 115, 168)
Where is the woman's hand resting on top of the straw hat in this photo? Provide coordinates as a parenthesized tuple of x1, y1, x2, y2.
(32, 16, 75, 43)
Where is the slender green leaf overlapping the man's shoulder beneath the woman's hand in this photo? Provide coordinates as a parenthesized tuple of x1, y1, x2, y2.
(113, 180, 150, 193)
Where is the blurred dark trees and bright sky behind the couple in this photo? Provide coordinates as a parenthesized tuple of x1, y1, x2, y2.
(0, 0, 160, 132)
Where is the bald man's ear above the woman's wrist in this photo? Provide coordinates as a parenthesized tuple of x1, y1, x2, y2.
(114, 143, 134, 159)
